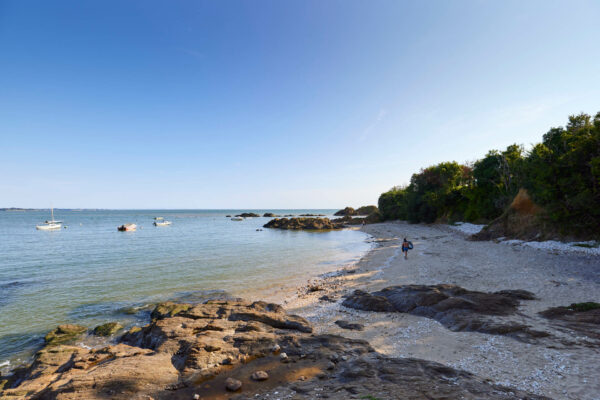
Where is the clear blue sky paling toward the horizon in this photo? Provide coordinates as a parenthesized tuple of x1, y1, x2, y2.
(0, 0, 600, 208)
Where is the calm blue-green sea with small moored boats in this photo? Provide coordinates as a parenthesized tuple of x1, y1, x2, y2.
(0, 210, 369, 370)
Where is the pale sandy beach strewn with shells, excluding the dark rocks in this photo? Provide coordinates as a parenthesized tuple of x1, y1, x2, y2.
(280, 222, 600, 400)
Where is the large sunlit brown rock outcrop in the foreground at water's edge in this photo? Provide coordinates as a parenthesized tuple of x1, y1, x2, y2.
(0, 301, 544, 400)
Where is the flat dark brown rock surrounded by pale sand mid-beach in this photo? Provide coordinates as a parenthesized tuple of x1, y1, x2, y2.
(342, 284, 548, 341)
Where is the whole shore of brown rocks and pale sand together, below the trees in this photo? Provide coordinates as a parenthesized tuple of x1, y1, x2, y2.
(0, 223, 600, 400)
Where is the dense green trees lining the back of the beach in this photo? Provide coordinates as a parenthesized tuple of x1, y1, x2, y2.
(379, 112, 600, 237)
